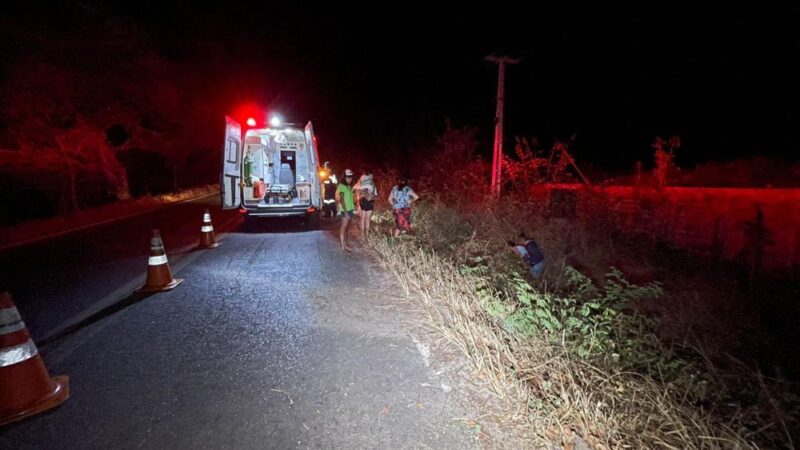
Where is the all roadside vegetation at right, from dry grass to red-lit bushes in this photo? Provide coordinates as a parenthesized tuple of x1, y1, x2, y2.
(370, 128, 800, 449)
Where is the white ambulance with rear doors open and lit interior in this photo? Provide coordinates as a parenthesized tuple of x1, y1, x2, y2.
(220, 117, 322, 225)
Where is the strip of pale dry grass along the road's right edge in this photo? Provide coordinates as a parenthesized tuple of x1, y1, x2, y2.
(371, 205, 792, 449)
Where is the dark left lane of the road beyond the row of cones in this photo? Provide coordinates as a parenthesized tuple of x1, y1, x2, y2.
(0, 194, 241, 342)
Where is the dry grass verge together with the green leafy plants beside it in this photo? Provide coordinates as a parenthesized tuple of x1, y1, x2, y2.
(371, 201, 792, 449)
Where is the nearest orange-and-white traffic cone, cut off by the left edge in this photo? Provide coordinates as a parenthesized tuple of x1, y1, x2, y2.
(0, 292, 69, 425)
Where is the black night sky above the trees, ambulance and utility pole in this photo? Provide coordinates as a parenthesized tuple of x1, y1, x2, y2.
(1, 2, 800, 172)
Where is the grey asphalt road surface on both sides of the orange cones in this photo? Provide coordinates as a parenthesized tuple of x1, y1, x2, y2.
(0, 199, 476, 449)
